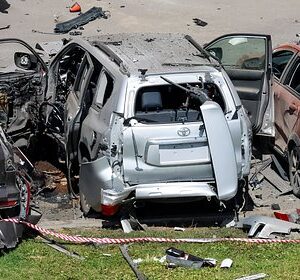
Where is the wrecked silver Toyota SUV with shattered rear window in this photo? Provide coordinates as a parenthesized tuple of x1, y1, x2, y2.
(48, 34, 270, 215)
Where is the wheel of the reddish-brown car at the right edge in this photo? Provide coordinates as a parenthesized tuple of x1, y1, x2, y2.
(288, 146, 300, 198)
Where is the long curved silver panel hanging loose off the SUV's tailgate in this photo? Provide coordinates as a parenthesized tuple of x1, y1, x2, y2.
(201, 101, 238, 200)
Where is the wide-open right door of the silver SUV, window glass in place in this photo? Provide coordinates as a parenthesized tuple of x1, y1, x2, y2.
(205, 34, 274, 136)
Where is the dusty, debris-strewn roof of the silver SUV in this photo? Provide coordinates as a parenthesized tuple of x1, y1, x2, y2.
(88, 33, 218, 75)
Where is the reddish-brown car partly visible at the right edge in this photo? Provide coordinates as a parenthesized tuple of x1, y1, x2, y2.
(273, 44, 300, 197)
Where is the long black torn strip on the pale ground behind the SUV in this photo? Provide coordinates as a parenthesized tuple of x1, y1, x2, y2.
(54, 7, 107, 33)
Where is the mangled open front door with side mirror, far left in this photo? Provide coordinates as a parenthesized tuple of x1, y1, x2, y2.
(0, 39, 48, 138)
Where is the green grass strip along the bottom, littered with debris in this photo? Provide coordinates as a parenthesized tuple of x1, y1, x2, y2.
(0, 228, 300, 280)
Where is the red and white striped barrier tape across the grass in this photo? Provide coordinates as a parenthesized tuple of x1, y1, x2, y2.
(2, 219, 300, 244)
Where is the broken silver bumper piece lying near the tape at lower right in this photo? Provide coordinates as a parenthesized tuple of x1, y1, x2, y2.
(237, 216, 300, 238)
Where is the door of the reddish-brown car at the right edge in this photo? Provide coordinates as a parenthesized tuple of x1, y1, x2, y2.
(274, 53, 300, 153)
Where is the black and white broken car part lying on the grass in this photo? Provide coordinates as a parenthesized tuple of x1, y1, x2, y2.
(166, 247, 217, 268)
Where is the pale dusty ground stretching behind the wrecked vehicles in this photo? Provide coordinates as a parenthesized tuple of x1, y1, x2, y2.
(0, 0, 300, 46)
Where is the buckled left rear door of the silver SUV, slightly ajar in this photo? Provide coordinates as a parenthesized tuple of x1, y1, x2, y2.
(65, 53, 94, 161)
